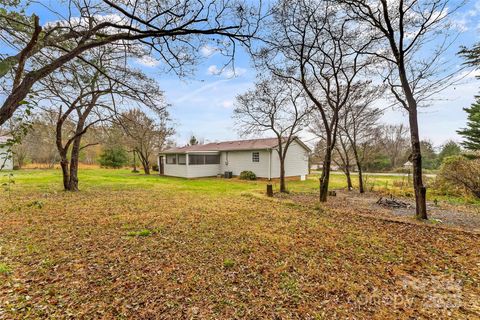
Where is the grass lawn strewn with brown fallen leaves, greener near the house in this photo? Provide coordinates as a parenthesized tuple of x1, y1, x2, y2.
(0, 169, 480, 319)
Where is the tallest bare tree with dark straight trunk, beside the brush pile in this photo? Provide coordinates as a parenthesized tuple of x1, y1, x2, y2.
(341, 0, 464, 219)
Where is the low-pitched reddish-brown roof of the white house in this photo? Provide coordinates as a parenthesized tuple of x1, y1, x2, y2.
(162, 138, 310, 153)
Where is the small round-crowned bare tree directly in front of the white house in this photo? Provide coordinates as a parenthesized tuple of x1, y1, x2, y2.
(234, 77, 309, 192)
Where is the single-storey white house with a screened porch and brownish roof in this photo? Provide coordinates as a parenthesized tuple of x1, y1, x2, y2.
(158, 138, 310, 179)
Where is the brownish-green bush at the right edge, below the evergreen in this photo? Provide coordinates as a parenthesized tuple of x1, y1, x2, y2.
(436, 156, 480, 198)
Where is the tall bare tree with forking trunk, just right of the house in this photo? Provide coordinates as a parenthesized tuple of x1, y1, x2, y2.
(256, 0, 370, 202)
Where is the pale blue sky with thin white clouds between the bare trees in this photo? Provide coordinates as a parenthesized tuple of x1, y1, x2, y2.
(28, 0, 480, 146)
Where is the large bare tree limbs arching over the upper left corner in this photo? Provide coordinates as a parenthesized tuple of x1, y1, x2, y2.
(0, 0, 260, 126)
